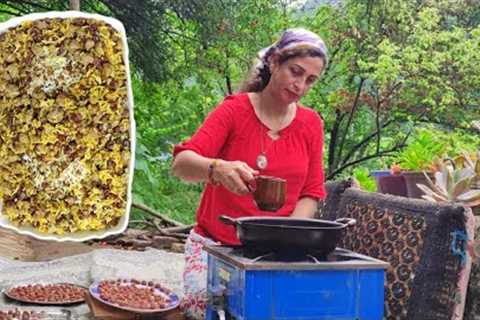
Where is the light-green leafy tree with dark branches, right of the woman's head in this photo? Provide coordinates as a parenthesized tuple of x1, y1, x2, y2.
(305, 0, 480, 178)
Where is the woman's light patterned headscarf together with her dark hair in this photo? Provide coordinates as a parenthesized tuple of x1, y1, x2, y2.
(239, 28, 328, 92)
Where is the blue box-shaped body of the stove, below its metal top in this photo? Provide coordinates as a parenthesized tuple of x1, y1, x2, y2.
(206, 255, 384, 320)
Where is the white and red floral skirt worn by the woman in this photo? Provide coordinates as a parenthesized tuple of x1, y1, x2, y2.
(180, 230, 217, 319)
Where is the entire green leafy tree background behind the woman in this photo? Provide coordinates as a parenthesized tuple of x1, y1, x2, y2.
(0, 0, 480, 223)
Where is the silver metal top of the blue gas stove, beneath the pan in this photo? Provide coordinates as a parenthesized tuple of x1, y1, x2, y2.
(204, 245, 388, 270)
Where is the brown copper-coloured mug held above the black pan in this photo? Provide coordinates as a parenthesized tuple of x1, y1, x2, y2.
(249, 176, 287, 212)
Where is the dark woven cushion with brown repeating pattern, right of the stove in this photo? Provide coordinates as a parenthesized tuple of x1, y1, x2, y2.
(339, 189, 466, 320)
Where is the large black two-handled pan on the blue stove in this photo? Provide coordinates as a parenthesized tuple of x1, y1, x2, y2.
(220, 216, 356, 255)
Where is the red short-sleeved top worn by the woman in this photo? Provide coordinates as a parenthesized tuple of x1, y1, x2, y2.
(174, 93, 326, 244)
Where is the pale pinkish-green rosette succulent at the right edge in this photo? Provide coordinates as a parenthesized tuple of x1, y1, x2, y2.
(417, 162, 480, 207)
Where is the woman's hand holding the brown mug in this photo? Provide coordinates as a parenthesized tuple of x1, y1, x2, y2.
(212, 160, 259, 195)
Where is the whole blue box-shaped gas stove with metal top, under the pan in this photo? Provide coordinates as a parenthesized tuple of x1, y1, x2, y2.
(205, 246, 388, 320)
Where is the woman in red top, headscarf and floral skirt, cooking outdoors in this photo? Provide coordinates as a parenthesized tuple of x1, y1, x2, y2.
(172, 29, 328, 319)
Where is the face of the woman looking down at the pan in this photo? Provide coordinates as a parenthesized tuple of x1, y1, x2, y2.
(268, 57, 324, 105)
